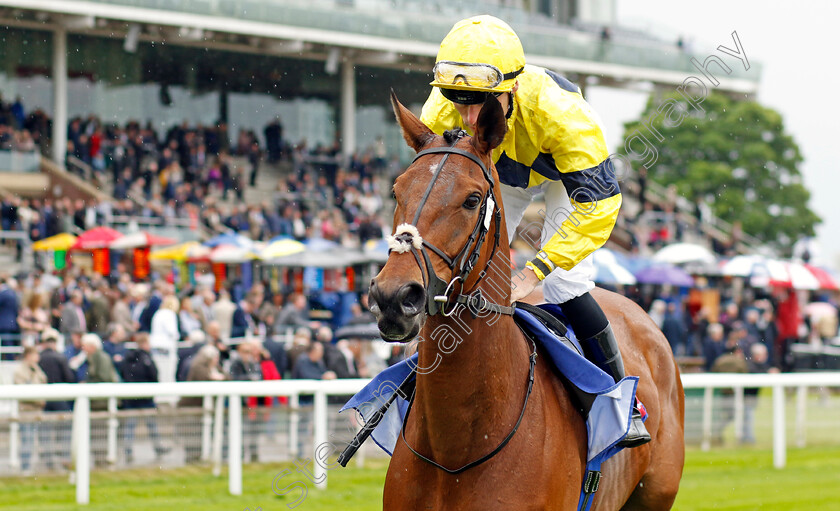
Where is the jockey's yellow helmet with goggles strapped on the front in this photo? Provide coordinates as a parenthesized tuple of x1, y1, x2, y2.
(430, 15, 525, 101)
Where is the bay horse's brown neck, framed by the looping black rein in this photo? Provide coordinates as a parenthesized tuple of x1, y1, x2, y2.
(410, 242, 529, 467)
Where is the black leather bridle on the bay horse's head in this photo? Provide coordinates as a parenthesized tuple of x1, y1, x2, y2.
(394, 130, 514, 317)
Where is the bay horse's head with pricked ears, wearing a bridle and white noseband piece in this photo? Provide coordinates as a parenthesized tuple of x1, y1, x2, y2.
(369, 92, 510, 342)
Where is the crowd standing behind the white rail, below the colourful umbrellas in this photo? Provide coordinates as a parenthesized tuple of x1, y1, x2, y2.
(0, 273, 400, 470)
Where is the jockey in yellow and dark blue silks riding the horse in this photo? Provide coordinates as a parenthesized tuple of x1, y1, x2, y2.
(421, 15, 650, 447)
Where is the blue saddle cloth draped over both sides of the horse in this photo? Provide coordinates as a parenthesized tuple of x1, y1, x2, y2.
(341, 305, 639, 510)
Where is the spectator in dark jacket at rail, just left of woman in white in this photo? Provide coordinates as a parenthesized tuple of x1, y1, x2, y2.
(122, 333, 172, 463)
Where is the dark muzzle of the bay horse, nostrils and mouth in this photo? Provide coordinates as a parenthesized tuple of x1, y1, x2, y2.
(368, 279, 426, 342)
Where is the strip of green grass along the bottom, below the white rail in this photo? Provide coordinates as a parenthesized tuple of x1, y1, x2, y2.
(0, 447, 840, 511)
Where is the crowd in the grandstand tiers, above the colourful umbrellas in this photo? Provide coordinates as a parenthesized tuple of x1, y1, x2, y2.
(0, 92, 385, 254)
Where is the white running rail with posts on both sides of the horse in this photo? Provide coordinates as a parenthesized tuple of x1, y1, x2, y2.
(0, 372, 840, 504)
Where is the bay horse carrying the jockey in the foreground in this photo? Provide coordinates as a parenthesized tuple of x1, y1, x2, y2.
(369, 92, 685, 511)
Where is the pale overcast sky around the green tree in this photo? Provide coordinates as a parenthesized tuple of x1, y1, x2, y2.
(587, 0, 840, 268)
